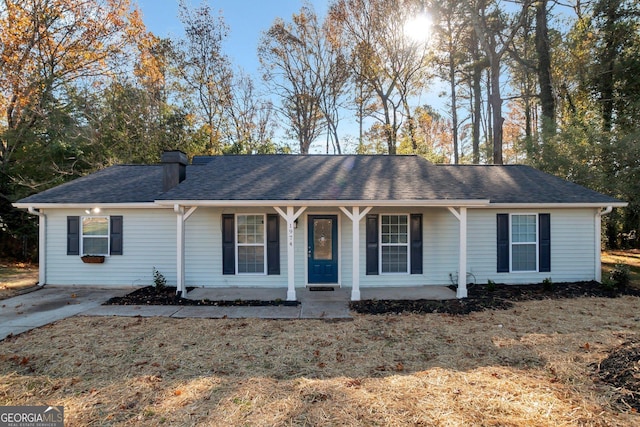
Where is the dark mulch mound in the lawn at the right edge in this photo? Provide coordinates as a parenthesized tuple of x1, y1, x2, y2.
(596, 339, 640, 412)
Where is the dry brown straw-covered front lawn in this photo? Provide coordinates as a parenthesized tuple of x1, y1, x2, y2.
(0, 296, 640, 426)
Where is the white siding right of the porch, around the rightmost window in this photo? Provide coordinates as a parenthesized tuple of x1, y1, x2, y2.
(467, 209, 597, 284)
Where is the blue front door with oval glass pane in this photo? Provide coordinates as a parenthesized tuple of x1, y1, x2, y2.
(307, 215, 338, 283)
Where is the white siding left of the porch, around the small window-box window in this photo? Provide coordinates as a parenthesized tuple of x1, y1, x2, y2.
(44, 209, 176, 286)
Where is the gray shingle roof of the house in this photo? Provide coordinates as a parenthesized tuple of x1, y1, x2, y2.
(19, 155, 619, 205)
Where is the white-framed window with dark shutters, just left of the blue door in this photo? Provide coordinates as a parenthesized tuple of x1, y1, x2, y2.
(236, 215, 267, 274)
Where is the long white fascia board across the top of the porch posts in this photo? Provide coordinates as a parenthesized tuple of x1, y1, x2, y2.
(156, 200, 490, 207)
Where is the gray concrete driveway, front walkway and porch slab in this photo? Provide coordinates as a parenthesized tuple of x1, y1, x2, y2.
(0, 286, 455, 340)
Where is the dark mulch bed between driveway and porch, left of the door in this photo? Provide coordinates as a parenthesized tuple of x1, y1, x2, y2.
(103, 286, 300, 307)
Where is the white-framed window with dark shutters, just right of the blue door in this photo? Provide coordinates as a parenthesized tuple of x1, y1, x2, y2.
(380, 215, 409, 273)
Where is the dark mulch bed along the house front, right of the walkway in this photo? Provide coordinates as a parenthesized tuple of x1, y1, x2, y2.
(349, 281, 640, 314)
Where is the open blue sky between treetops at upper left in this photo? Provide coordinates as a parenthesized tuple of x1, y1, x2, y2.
(137, 0, 329, 76)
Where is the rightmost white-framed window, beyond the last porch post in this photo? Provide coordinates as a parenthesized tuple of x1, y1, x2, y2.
(511, 214, 538, 271)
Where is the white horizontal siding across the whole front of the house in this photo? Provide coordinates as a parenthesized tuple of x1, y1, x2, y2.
(44, 207, 597, 288)
